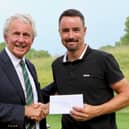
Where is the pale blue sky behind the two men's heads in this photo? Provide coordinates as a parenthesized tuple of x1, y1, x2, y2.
(0, 0, 129, 55)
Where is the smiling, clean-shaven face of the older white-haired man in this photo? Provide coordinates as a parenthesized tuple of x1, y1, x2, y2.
(4, 19, 34, 58)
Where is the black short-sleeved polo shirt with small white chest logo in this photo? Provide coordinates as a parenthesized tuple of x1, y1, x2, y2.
(52, 47, 124, 129)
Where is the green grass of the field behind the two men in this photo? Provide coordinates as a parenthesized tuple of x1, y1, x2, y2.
(32, 46, 129, 129)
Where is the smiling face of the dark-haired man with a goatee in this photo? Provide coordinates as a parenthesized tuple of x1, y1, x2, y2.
(59, 16, 86, 52)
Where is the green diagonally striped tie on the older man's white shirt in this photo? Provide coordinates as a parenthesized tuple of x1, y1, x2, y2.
(20, 60, 36, 129)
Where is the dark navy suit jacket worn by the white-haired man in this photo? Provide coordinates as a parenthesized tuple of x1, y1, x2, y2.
(0, 50, 46, 129)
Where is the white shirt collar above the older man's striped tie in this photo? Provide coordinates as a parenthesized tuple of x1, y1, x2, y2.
(5, 47, 25, 67)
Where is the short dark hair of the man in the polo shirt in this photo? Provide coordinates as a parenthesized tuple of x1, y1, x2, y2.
(59, 9, 85, 25)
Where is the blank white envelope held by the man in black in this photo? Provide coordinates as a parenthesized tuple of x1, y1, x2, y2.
(49, 94, 83, 114)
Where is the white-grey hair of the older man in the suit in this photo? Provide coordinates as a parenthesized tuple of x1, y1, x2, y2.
(3, 14, 37, 38)
